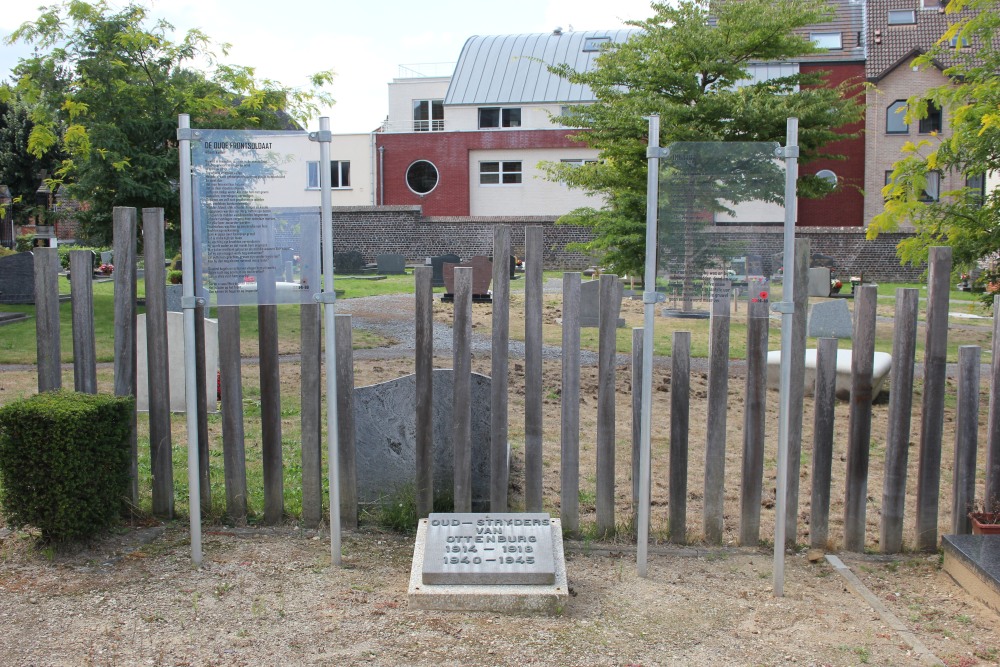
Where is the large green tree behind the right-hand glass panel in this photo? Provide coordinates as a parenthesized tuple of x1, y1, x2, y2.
(546, 0, 863, 275)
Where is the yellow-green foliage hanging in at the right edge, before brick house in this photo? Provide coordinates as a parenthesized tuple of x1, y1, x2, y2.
(868, 0, 1000, 301)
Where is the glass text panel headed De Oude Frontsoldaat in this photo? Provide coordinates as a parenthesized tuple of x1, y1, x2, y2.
(191, 130, 321, 306)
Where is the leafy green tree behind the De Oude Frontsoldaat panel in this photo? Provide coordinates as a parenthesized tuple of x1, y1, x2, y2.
(1, 0, 332, 243)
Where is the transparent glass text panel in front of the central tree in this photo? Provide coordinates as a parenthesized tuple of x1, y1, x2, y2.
(657, 142, 785, 317)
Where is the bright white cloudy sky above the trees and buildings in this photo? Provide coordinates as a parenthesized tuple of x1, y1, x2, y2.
(0, 0, 652, 134)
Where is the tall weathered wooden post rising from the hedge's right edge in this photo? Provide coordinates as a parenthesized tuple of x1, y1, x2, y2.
(112, 206, 138, 504)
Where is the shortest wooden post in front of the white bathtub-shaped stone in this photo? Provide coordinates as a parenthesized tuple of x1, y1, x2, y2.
(809, 338, 837, 549)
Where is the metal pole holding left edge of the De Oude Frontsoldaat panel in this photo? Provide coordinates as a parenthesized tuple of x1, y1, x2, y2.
(178, 114, 201, 565)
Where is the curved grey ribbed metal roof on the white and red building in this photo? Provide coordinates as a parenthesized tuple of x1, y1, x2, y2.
(444, 29, 638, 104)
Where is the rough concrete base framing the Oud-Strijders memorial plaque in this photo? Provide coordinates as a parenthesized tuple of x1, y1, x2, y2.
(407, 519, 569, 614)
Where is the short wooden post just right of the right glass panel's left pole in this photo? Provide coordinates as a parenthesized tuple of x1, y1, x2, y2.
(669, 331, 691, 544)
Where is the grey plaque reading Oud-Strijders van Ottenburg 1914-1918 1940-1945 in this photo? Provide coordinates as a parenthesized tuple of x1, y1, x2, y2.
(423, 512, 556, 586)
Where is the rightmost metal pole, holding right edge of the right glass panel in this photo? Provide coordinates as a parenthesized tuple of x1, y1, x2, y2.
(772, 118, 799, 597)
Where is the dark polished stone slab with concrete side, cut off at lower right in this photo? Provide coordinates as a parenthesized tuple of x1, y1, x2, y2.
(941, 535, 1000, 612)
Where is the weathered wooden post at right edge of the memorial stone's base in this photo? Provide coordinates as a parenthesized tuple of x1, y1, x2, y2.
(559, 272, 580, 535)
